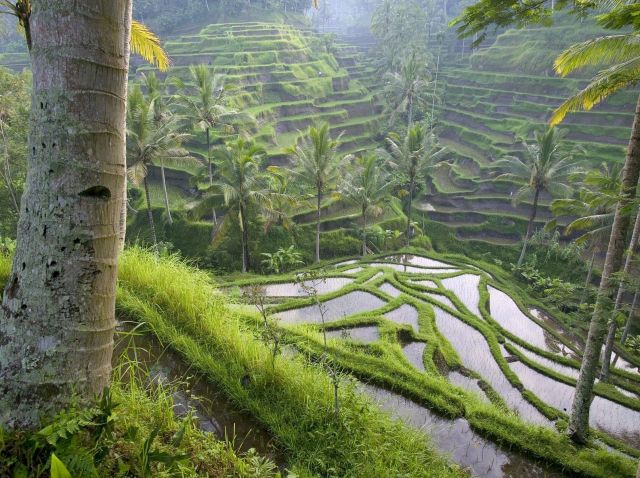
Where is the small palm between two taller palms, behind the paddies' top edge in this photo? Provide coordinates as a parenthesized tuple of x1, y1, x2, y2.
(343, 154, 393, 256)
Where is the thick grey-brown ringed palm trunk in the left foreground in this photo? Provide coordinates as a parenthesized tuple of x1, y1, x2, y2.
(0, 0, 131, 429)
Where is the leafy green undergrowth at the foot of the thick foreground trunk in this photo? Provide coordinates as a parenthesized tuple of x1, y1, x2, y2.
(0, 348, 279, 478)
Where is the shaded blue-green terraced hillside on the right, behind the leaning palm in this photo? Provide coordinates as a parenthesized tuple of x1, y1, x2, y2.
(422, 19, 637, 245)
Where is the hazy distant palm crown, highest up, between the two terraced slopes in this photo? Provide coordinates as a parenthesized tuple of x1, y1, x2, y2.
(385, 52, 429, 130)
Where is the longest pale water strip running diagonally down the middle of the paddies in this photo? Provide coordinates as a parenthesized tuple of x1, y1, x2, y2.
(433, 307, 551, 426)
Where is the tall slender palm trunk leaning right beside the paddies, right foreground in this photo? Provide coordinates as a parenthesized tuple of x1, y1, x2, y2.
(568, 92, 640, 443)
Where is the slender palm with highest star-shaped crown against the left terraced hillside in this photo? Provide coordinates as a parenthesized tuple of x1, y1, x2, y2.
(173, 65, 238, 185)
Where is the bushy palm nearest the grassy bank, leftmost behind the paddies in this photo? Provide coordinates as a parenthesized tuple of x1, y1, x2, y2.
(213, 138, 269, 273)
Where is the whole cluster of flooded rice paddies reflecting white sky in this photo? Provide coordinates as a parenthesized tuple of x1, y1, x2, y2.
(244, 256, 640, 477)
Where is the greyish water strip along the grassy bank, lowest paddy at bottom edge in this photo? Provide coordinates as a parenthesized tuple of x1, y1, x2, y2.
(360, 384, 563, 478)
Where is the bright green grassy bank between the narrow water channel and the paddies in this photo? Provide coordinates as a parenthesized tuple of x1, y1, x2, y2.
(118, 249, 466, 477)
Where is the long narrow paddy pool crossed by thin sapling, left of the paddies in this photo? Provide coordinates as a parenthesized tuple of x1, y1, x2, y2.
(274, 291, 385, 324)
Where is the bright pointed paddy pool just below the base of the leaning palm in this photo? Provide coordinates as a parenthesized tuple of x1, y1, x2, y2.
(489, 287, 562, 353)
